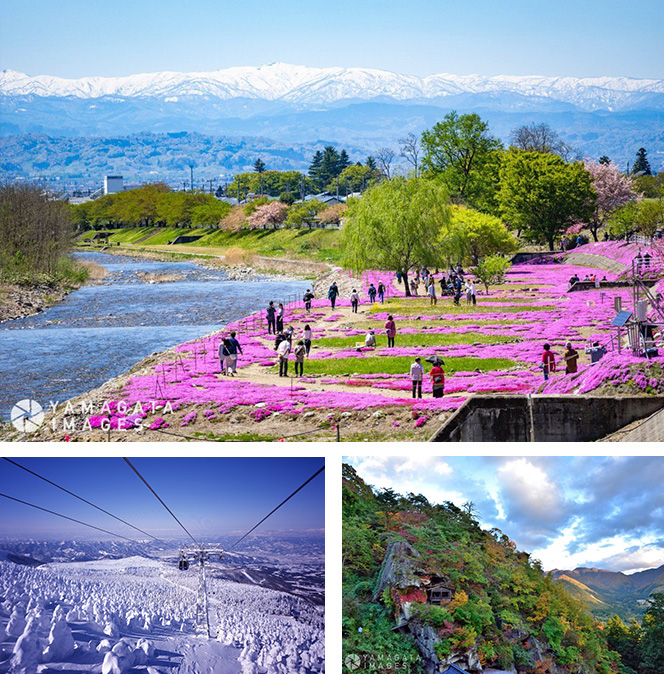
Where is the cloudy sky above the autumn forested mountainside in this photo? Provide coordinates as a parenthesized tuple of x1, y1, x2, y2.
(345, 456, 664, 573)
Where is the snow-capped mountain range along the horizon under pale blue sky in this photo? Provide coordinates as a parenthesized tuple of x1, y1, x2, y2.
(0, 63, 664, 111)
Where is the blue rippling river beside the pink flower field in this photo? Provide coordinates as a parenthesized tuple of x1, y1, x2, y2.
(0, 253, 310, 420)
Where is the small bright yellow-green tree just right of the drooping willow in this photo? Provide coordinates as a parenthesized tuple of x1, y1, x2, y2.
(440, 206, 518, 265)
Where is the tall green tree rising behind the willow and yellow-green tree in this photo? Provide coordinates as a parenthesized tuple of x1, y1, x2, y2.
(422, 112, 502, 206)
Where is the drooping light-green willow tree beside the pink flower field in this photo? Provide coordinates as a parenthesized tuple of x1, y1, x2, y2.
(342, 177, 450, 295)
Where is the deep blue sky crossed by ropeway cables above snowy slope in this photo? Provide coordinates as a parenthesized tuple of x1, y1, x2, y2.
(0, 457, 325, 539)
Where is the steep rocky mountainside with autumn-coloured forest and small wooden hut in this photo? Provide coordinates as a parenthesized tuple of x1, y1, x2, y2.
(343, 466, 620, 674)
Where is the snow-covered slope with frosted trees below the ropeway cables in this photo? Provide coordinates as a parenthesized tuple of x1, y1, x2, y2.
(0, 557, 325, 674)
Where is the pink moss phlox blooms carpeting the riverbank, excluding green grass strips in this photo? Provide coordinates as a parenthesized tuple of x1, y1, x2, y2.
(81, 242, 664, 429)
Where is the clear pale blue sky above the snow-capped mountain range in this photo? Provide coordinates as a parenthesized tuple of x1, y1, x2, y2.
(0, 0, 664, 78)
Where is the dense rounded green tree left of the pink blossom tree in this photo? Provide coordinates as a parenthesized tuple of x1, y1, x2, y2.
(498, 150, 596, 250)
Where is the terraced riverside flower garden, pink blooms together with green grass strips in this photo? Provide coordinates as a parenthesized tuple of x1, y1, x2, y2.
(85, 242, 659, 428)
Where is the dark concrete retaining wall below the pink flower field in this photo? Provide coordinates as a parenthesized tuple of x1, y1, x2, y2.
(430, 395, 664, 442)
